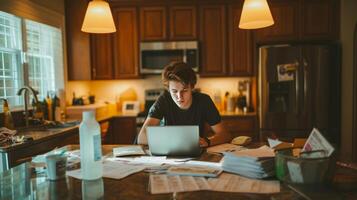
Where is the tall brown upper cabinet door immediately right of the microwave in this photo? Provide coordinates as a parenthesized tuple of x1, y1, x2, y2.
(199, 5, 227, 76)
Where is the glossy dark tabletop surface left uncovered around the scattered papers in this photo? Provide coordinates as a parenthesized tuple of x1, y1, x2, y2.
(0, 145, 357, 200)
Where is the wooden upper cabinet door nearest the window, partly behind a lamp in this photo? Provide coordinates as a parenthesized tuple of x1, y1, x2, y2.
(65, 0, 91, 81)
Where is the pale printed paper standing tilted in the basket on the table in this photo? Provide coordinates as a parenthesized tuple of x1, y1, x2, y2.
(302, 128, 335, 156)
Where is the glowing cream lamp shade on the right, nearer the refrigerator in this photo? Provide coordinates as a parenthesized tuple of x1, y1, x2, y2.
(239, 0, 274, 29)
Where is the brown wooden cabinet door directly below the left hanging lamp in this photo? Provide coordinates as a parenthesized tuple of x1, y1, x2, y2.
(91, 34, 114, 80)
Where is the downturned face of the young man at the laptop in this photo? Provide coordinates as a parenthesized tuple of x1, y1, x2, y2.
(169, 81, 192, 109)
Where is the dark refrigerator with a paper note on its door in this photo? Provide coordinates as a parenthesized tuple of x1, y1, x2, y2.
(259, 44, 340, 145)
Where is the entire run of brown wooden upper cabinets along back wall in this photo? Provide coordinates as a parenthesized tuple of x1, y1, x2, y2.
(65, 0, 340, 80)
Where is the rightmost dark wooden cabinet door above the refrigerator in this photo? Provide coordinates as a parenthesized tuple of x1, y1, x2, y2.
(301, 0, 340, 40)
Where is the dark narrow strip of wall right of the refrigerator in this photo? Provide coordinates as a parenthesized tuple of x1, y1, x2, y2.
(340, 0, 357, 161)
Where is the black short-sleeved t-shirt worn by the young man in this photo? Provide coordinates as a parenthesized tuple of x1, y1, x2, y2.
(148, 91, 221, 137)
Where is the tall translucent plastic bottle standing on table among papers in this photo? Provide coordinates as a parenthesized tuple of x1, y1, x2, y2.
(79, 111, 103, 180)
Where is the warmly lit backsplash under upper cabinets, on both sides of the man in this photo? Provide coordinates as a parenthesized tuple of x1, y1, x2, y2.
(66, 76, 251, 109)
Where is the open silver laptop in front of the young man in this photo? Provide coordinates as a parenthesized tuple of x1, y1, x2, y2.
(146, 126, 201, 156)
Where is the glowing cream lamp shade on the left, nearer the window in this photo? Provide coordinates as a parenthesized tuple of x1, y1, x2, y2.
(81, 0, 116, 33)
